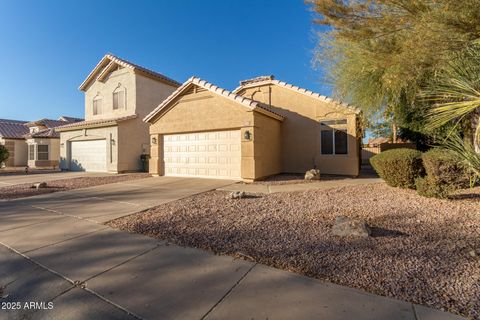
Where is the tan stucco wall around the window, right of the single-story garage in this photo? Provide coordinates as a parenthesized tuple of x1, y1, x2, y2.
(240, 84, 360, 176)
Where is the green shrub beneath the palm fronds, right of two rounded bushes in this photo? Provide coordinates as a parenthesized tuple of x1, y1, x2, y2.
(422, 148, 470, 188)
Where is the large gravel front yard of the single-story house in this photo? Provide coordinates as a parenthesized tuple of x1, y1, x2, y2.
(109, 183, 480, 319)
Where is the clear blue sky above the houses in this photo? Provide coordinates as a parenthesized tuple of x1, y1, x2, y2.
(0, 0, 331, 120)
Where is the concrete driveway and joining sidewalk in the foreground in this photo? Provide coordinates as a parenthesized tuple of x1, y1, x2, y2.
(0, 177, 461, 320)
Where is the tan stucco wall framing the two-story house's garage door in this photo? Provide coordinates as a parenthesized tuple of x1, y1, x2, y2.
(60, 126, 118, 173)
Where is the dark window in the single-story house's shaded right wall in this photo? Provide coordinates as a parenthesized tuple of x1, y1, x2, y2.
(320, 119, 348, 155)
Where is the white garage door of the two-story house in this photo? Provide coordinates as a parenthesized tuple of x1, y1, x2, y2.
(70, 140, 107, 172)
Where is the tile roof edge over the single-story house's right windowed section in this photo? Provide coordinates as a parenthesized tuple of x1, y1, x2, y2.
(232, 75, 361, 114)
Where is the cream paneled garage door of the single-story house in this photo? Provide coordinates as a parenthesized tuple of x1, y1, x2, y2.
(163, 130, 241, 179)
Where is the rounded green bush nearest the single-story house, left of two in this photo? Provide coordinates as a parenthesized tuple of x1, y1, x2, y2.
(370, 148, 424, 189)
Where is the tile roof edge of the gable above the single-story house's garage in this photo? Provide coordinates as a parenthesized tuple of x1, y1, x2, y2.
(143, 77, 284, 122)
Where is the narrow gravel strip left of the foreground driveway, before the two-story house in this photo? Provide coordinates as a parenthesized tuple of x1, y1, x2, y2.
(0, 173, 150, 200)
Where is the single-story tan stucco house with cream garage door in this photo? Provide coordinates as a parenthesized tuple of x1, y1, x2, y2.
(144, 76, 363, 181)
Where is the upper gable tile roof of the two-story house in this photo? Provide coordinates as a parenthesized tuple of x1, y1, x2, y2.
(79, 53, 181, 91)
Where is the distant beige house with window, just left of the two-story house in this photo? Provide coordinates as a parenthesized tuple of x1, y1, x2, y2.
(24, 116, 83, 168)
